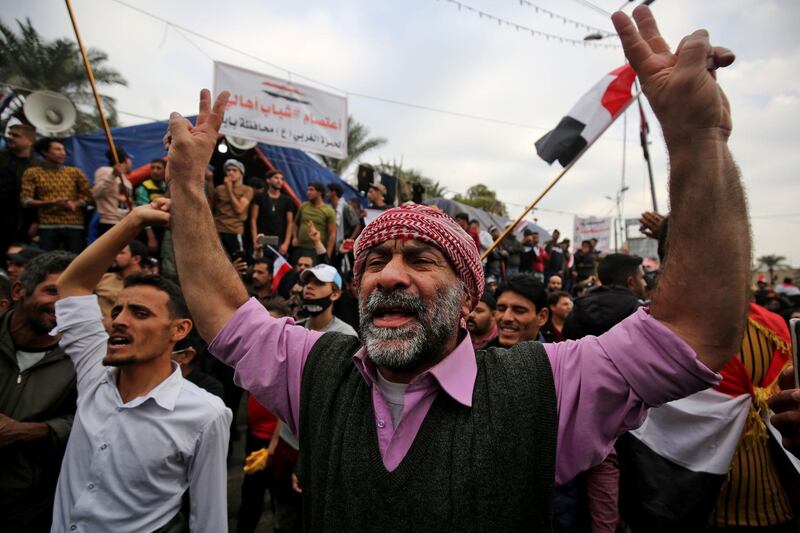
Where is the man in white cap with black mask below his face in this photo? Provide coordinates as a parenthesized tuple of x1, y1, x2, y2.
(300, 265, 358, 336)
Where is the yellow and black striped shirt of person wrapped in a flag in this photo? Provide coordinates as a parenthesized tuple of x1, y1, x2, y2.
(710, 320, 792, 527)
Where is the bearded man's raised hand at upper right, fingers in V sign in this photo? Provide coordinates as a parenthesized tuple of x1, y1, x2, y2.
(611, 5, 735, 145)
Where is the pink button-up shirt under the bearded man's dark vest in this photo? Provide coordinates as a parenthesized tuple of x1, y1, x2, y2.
(209, 299, 720, 483)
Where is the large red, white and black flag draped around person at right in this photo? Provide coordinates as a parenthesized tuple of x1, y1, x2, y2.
(616, 304, 800, 533)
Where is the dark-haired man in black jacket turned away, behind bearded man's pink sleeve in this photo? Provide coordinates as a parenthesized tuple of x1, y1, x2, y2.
(563, 254, 645, 339)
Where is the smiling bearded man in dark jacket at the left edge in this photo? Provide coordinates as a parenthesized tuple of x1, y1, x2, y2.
(0, 252, 77, 533)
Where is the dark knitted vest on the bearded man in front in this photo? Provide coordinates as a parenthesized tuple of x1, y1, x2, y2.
(298, 333, 557, 531)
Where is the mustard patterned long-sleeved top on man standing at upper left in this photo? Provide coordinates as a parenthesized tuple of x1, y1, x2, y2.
(19, 166, 92, 227)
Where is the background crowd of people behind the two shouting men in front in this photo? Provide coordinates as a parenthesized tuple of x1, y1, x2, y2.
(0, 120, 800, 531)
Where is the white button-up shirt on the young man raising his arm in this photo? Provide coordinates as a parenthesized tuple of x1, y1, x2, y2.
(52, 295, 231, 533)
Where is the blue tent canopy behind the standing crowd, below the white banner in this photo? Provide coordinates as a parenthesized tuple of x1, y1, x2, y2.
(64, 117, 358, 200)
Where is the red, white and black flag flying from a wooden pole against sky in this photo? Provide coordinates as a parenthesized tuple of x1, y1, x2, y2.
(536, 65, 636, 167)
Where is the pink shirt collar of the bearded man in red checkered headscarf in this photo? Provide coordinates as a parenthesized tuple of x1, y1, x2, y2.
(353, 329, 478, 407)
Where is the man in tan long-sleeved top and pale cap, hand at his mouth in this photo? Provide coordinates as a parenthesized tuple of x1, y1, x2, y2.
(214, 159, 253, 256)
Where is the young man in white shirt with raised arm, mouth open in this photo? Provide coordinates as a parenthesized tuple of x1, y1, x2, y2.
(53, 199, 231, 532)
